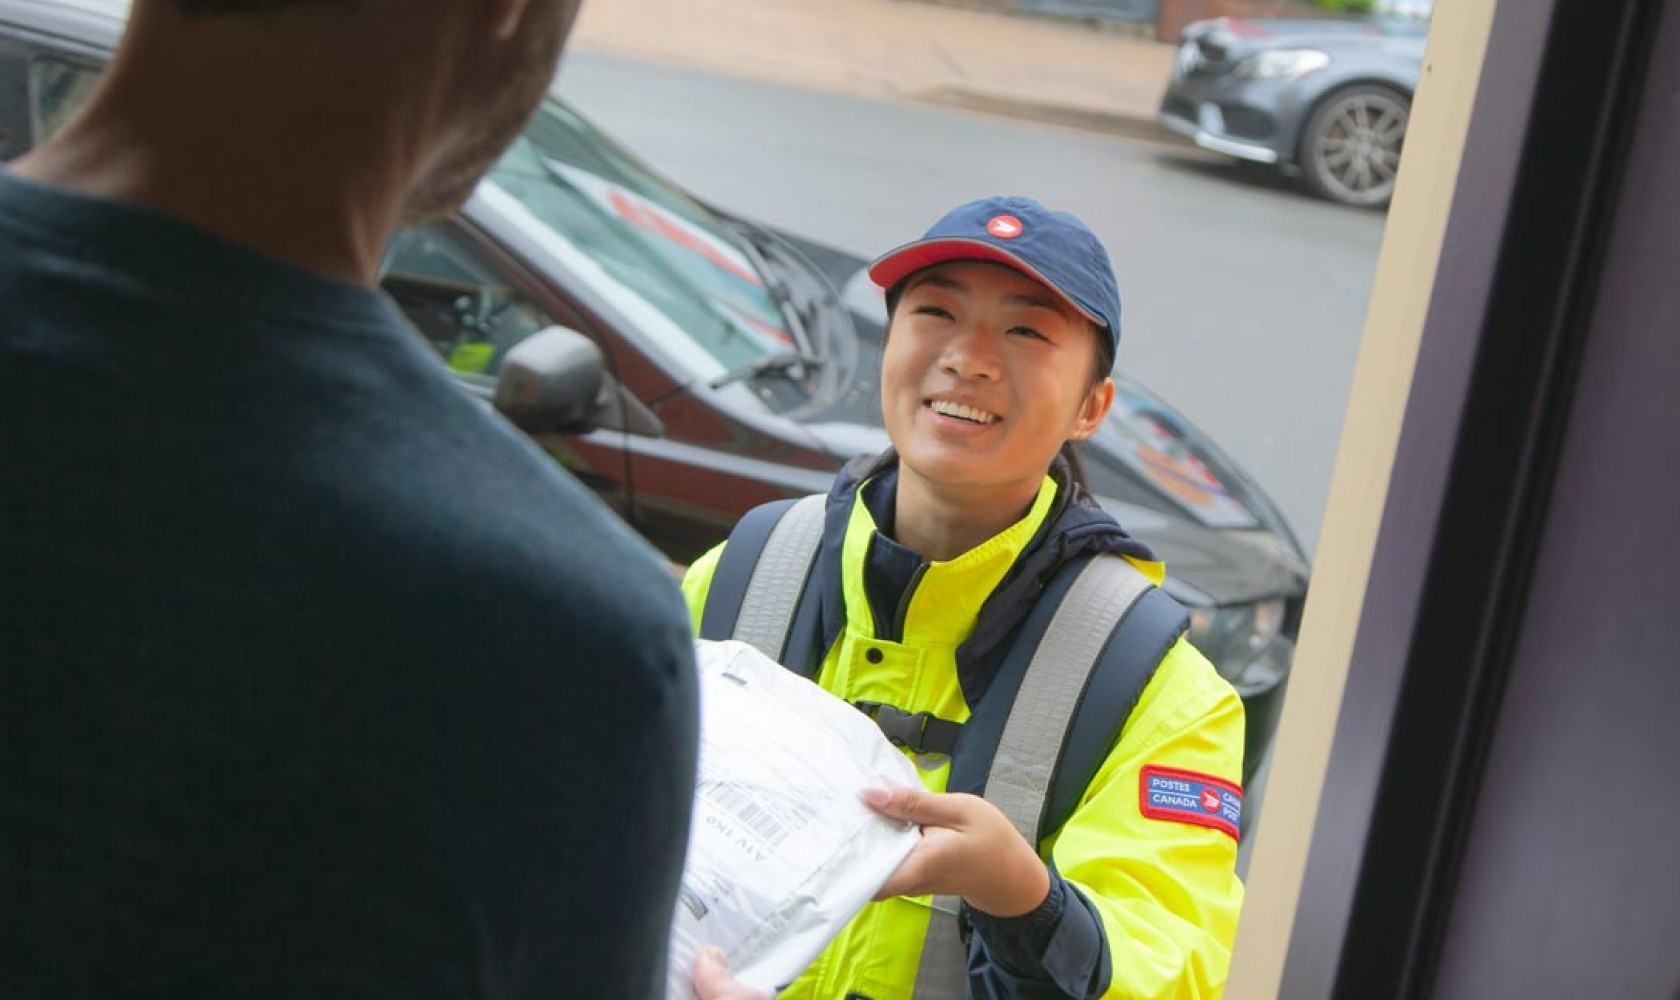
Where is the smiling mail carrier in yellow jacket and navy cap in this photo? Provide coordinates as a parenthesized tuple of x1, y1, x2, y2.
(684, 198, 1243, 1000)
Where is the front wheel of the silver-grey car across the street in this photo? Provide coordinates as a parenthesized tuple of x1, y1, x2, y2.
(1299, 84, 1411, 208)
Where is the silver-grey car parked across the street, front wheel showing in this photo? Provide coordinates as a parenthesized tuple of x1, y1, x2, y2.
(1159, 0, 1428, 208)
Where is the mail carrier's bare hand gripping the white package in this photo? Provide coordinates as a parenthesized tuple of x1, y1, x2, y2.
(864, 788, 1050, 918)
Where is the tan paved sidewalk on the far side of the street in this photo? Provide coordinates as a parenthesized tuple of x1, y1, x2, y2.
(573, 0, 1173, 138)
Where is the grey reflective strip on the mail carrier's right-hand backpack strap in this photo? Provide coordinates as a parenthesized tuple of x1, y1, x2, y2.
(986, 558, 1152, 844)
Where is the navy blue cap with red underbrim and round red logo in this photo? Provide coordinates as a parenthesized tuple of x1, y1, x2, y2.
(869, 197, 1121, 368)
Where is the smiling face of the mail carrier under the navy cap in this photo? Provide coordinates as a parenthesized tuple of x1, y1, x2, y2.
(880, 261, 1114, 516)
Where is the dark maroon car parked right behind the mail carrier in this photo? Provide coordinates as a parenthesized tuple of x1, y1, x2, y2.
(0, 0, 1307, 783)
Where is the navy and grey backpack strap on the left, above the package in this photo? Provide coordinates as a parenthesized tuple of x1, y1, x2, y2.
(701, 494, 825, 662)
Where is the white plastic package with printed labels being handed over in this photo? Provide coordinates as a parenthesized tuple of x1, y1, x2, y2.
(665, 640, 921, 1000)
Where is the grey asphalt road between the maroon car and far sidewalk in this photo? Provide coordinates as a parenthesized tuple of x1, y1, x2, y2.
(559, 52, 1384, 553)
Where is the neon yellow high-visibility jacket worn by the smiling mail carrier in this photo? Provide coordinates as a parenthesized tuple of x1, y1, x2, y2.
(682, 469, 1243, 1000)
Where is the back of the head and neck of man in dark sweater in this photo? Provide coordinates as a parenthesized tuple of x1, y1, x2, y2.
(113, 0, 580, 222)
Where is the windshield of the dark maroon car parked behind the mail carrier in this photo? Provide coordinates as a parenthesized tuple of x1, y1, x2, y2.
(487, 99, 795, 378)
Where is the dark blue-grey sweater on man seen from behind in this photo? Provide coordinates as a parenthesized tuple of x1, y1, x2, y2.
(0, 171, 696, 1000)
